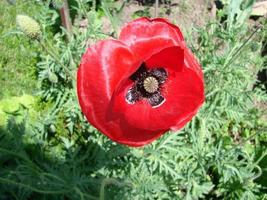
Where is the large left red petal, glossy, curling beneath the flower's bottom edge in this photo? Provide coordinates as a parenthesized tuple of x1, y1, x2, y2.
(77, 40, 166, 146)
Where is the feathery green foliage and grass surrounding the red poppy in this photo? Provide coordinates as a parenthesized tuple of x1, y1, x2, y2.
(0, 0, 267, 200)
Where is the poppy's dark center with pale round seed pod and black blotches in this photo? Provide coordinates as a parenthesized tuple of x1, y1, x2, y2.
(125, 63, 167, 107)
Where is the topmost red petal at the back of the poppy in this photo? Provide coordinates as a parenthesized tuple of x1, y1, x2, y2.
(119, 18, 184, 60)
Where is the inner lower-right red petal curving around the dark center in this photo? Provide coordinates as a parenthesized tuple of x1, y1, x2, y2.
(112, 47, 204, 130)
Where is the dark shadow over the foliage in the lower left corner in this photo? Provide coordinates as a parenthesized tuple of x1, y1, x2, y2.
(0, 115, 132, 199)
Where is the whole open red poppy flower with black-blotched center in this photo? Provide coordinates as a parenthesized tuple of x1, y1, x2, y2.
(77, 18, 204, 146)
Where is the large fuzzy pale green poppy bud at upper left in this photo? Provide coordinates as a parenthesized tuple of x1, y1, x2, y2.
(16, 15, 41, 39)
